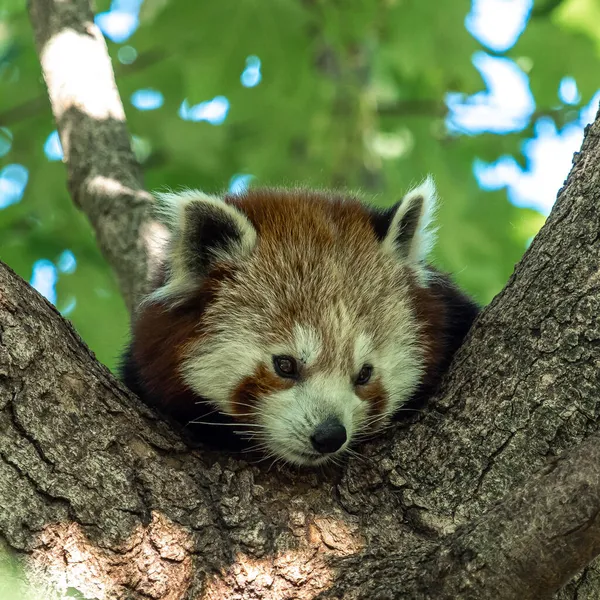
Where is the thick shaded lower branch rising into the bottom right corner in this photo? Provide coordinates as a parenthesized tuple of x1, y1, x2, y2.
(320, 428, 600, 600)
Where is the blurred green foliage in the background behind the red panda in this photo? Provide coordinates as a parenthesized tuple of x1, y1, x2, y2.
(0, 0, 600, 367)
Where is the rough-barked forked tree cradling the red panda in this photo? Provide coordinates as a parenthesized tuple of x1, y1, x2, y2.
(0, 0, 600, 599)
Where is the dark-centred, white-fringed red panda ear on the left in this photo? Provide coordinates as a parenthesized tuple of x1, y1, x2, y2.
(152, 190, 256, 300)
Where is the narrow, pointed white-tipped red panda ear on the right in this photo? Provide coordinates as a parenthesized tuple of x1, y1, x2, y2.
(373, 177, 436, 280)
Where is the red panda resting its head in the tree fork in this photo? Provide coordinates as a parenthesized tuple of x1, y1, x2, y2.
(122, 179, 478, 465)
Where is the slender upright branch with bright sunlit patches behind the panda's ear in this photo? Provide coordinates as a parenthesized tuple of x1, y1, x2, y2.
(28, 0, 164, 311)
